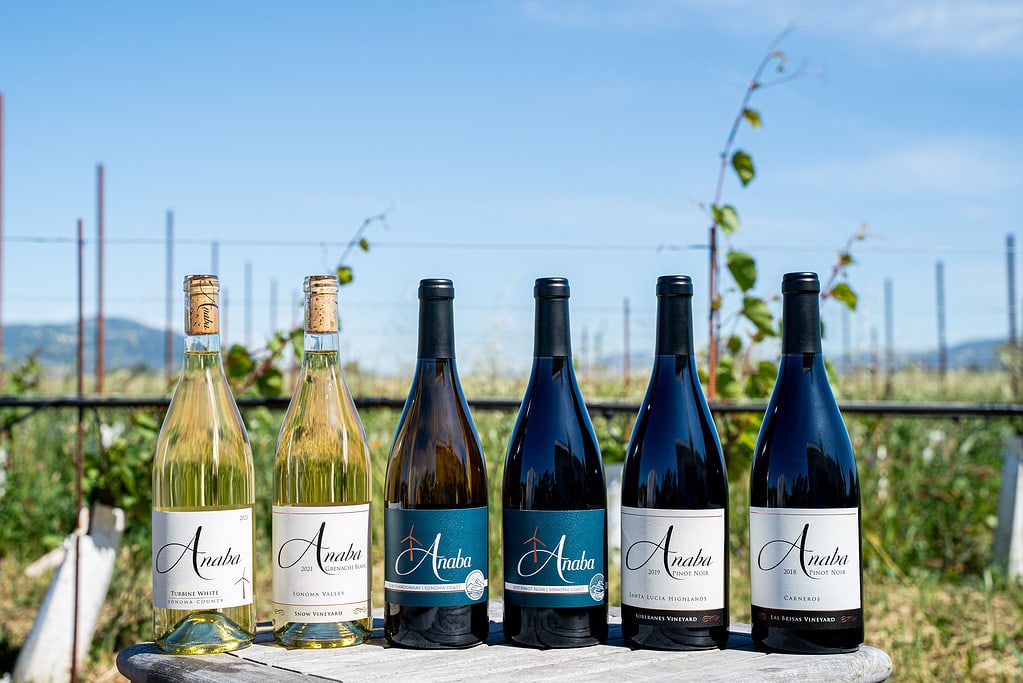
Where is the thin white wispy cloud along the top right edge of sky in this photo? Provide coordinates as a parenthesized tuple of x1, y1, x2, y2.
(522, 0, 1023, 56)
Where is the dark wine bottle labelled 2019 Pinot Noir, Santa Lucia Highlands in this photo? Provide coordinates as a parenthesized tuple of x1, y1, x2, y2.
(621, 275, 728, 650)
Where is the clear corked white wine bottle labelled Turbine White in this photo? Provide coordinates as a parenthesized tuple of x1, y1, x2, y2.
(152, 275, 256, 654)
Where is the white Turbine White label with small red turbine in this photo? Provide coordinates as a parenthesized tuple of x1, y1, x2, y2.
(152, 505, 253, 609)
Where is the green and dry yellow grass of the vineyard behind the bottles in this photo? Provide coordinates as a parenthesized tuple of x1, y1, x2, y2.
(0, 371, 1023, 681)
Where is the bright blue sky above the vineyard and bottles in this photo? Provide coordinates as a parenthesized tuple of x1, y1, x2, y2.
(0, 0, 1023, 372)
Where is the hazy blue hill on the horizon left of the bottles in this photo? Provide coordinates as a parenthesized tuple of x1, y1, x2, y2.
(3, 318, 184, 372)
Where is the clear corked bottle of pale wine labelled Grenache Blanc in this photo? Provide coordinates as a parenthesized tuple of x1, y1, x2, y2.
(272, 275, 372, 648)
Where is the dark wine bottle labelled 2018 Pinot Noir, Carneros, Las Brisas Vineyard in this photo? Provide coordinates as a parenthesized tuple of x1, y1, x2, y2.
(750, 273, 863, 653)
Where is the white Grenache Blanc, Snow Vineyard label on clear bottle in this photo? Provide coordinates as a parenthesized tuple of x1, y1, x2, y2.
(273, 503, 370, 625)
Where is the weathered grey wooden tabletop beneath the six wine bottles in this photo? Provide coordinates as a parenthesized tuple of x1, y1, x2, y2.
(118, 600, 892, 683)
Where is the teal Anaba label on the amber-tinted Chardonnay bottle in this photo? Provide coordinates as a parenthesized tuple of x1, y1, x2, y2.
(384, 507, 490, 606)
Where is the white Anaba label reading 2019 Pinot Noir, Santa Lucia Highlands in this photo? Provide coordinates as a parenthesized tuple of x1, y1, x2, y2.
(622, 506, 726, 628)
